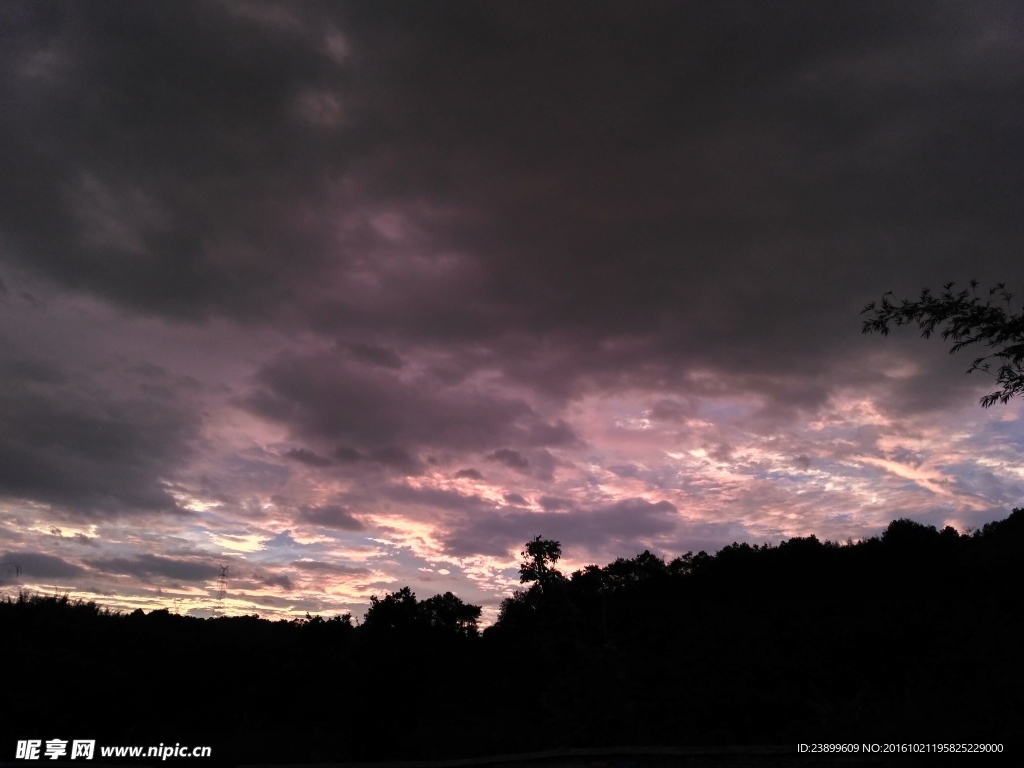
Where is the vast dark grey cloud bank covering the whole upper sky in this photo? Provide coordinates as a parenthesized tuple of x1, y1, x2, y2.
(0, 3, 1024, 415)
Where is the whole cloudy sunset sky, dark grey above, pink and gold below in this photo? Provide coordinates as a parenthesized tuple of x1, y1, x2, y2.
(0, 0, 1024, 623)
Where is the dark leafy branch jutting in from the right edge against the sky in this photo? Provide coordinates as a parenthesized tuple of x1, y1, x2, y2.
(860, 280, 1024, 408)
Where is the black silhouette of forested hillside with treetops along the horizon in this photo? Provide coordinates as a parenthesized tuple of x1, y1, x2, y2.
(0, 509, 1024, 765)
